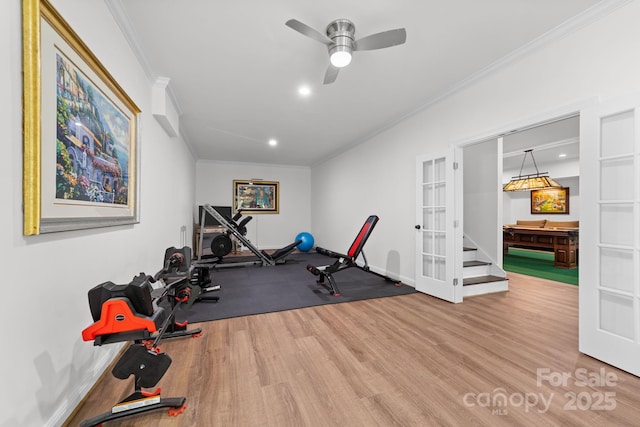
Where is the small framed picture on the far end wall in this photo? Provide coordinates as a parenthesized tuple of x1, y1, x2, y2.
(233, 180, 280, 214)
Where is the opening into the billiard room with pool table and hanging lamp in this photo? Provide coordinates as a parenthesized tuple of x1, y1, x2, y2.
(502, 115, 580, 285)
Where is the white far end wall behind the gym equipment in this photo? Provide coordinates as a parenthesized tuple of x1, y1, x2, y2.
(194, 160, 311, 249)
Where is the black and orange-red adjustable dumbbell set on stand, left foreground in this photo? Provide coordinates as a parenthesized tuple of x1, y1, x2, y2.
(80, 248, 202, 427)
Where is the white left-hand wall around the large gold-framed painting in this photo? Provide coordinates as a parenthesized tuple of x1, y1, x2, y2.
(0, 0, 195, 427)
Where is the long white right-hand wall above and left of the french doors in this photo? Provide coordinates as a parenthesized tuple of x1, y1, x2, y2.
(311, 2, 640, 286)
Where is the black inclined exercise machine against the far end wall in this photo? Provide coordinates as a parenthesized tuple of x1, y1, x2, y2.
(197, 204, 302, 268)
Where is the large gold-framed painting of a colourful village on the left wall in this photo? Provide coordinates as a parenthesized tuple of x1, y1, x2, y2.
(22, 0, 140, 236)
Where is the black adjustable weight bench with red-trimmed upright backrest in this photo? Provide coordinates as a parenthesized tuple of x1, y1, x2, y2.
(307, 215, 402, 297)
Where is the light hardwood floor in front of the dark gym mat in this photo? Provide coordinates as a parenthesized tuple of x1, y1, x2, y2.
(68, 274, 640, 427)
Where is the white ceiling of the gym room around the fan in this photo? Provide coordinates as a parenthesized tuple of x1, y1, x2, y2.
(106, 0, 599, 166)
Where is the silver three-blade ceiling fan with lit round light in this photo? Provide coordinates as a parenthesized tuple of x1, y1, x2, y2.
(285, 19, 407, 84)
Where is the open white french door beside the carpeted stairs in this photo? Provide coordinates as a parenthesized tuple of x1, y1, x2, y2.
(415, 148, 463, 302)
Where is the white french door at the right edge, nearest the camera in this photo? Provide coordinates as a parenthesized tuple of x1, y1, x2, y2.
(579, 96, 640, 376)
